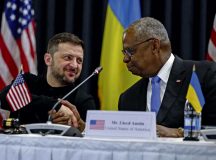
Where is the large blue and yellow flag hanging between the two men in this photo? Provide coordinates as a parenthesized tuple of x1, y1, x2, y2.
(98, 0, 141, 110)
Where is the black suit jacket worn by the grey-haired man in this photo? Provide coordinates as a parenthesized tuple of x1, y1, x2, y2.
(118, 56, 216, 128)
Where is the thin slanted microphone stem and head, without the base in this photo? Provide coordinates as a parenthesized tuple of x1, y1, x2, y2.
(47, 66, 103, 123)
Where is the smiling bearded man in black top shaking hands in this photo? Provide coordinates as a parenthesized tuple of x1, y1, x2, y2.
(0, 33, 96, 131)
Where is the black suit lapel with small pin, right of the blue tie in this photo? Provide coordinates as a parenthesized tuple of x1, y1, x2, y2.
(157, 57, 186, 124)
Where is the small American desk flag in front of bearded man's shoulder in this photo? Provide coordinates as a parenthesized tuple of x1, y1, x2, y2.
(6, 73, 32, 111)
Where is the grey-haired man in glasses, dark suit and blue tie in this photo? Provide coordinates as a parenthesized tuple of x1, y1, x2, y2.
(118, 17, 216, 137)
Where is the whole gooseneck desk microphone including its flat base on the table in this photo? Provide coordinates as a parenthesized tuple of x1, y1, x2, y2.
(25, 66, 103, 137)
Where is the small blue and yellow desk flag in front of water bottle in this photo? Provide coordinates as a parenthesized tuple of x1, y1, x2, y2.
(186, 65, 205, 113)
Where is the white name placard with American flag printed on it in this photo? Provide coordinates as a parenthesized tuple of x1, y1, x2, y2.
(85, 111, 156, 139)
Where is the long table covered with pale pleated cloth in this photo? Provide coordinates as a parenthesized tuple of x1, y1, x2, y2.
(0, 134, 216, 160)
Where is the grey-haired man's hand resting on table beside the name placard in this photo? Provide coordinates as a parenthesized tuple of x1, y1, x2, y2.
(157, 125, 184, 138)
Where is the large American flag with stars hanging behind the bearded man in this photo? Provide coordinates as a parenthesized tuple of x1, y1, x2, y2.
(0, 0, 37, 90)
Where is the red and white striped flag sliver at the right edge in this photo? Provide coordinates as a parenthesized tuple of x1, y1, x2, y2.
(207, 14, 216, 61)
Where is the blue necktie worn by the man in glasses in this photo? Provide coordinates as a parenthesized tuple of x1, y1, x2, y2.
(151, 76, 161, 114)
